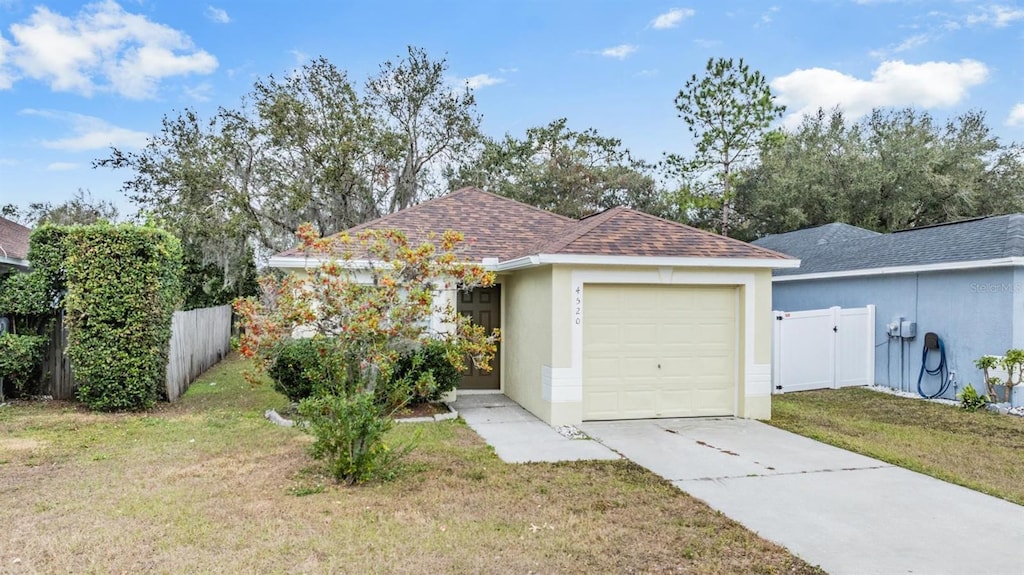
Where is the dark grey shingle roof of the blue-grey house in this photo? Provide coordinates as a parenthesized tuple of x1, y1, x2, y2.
(754, 214, 1024, 276)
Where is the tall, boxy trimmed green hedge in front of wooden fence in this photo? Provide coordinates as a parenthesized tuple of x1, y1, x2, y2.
(63, 224, 181, 410)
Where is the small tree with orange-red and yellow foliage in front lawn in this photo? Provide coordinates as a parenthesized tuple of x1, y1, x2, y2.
(234, 225, 500, 483)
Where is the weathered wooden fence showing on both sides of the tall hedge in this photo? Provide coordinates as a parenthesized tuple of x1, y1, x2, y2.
(40, 305, 231, 401)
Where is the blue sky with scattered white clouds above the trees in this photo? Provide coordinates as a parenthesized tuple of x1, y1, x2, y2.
(0, 0, 1024, 216)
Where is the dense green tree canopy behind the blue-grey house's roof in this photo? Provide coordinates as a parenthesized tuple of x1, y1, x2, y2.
(736, 108, 1024, 239)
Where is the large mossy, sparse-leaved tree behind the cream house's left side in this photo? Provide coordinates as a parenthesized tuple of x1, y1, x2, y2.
(94, 48, 479, 303)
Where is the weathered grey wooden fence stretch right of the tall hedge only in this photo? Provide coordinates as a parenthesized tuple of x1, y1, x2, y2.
(167, 305, 231, 401)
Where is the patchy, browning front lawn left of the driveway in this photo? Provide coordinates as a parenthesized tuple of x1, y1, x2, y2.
(0, 357, 821, 574)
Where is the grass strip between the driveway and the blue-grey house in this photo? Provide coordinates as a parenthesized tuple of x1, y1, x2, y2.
(769, 388, 1024, 505)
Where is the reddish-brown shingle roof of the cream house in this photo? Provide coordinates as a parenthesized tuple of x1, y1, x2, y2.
(270, 187, 796, 267)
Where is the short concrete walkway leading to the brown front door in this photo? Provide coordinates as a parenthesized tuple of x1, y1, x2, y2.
(454, 394, 621, 463)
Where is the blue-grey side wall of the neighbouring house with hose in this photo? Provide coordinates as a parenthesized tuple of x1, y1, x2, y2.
(772, 267, 1024, 404)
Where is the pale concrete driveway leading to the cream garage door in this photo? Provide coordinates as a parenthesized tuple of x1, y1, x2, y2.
(580, 418, 1024, 575)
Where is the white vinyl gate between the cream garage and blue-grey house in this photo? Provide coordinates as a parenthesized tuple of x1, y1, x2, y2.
(772, 306, 874, 393)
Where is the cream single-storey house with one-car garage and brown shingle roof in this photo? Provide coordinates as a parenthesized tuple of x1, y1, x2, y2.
(270, 188, 799, 425)
